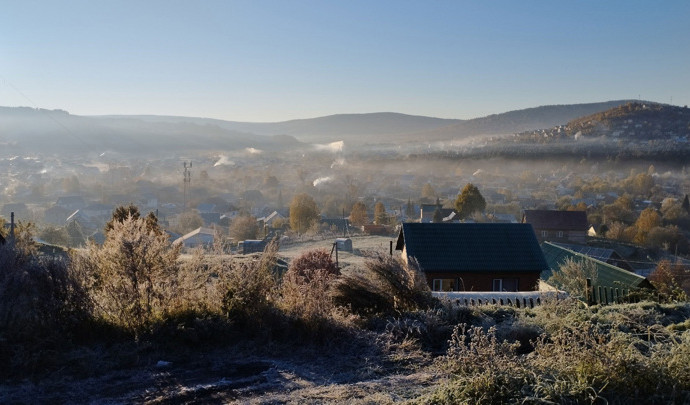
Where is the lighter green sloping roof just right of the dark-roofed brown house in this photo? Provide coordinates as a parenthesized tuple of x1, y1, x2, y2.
(541, 242, 651, 288)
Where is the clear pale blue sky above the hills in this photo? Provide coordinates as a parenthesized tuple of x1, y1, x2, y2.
(0, 0, 690, 122)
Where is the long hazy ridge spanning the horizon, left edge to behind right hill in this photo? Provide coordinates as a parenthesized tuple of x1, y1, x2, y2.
(0, 100, 652, 155)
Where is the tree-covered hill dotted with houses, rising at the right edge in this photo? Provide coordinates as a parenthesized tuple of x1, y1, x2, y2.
(432, 102, 690, 164)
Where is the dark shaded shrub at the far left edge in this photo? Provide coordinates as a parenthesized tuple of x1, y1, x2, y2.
(0, 229, 90, 378)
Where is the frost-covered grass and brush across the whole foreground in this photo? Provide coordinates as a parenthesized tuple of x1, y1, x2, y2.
(0, 227, 690, 403)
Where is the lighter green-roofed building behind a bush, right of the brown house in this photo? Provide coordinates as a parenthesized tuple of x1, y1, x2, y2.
(541, 242, 653, 304)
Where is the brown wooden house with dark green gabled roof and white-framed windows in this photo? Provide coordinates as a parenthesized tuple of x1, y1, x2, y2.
(396, 223, 549, 291)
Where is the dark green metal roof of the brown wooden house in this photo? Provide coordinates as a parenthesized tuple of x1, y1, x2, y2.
(396, 223, 548, 272)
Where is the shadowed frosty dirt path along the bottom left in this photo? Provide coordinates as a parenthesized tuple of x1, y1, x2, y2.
(0, 351, 441, 404)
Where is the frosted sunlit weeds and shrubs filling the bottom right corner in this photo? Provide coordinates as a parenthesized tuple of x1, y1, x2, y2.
(419, 303, 690, 403)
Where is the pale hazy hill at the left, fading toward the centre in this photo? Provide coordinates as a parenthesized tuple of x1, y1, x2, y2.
(0, 107, 300, 156)
